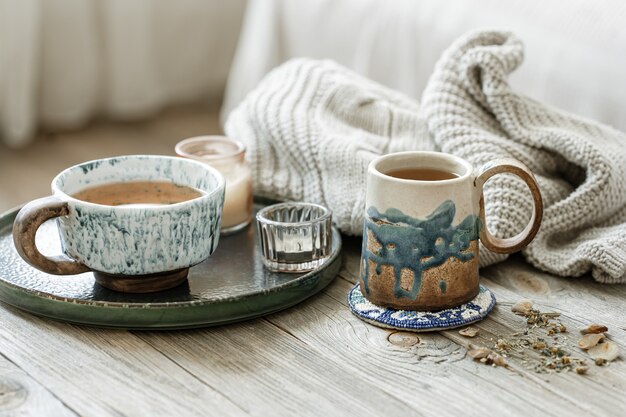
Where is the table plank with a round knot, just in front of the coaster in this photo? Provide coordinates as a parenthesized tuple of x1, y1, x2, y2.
(269, 279, 584, 416)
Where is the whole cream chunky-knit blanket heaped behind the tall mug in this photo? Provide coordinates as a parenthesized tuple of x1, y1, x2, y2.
(225, 31, 626, 283)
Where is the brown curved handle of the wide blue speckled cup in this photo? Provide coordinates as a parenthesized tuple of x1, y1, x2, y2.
(13, 196, 90, 275)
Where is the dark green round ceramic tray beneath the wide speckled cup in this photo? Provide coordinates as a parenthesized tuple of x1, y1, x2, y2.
(0, 205, 341, 329)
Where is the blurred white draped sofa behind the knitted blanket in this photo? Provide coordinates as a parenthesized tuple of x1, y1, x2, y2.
(222, 0, 626, 130)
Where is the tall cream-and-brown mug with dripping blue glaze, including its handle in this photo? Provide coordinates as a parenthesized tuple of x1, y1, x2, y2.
(360, 152, 543, 311)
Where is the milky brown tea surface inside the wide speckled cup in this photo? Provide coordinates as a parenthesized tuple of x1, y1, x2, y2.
(73, 181, 204, 206)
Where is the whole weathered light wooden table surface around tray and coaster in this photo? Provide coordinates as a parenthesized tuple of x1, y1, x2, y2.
(0, 234, 626, 417)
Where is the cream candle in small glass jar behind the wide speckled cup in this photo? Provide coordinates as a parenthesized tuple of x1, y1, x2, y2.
(176, 136, 252, 234)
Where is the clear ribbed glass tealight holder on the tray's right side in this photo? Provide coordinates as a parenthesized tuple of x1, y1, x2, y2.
(256, 203, 333, 273)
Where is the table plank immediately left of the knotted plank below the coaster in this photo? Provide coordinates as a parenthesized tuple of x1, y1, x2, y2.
(138, 320, 423, 417)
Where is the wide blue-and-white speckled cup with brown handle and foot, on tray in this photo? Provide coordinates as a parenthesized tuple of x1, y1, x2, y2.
(13, 155, 225, 292)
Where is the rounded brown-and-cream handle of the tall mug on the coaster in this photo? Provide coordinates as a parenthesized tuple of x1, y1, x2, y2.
(474, 158, 543, 253)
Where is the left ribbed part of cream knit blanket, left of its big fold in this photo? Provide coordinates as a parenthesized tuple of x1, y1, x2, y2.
(225, 59, 435, 235)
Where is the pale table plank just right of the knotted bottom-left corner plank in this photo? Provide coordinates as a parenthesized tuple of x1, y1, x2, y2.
(0, 307, 246, 416)
